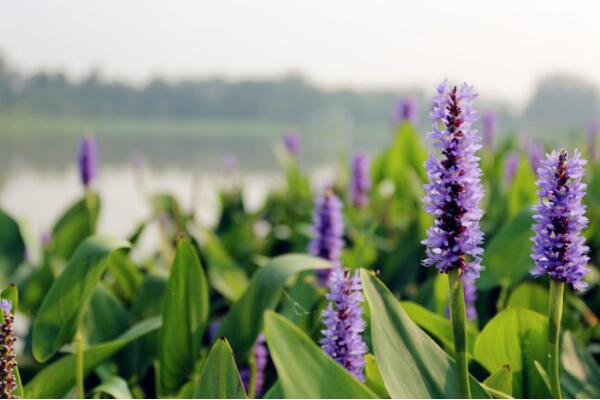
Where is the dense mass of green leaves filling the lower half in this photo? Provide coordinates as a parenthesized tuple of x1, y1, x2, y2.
(0, 104, 600, 398)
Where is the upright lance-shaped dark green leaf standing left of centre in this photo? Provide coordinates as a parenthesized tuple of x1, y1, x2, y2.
(159, 239, 209, 393)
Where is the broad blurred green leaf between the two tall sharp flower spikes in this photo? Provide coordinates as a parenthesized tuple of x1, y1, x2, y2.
(477, 210, 533, 290)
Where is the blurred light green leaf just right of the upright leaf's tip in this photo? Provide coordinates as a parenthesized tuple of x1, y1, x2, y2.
(202, 232, 248, 301)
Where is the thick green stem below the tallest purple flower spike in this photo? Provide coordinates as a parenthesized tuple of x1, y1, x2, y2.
(448, 268, 471, 399)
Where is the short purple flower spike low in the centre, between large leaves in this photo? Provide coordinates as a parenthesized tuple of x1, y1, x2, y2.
(321, 268, 367, 381)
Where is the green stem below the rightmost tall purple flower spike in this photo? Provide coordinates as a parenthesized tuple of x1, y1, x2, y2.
(546, 279, 565, 399)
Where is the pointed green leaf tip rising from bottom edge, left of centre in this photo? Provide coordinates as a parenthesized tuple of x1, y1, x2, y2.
(194, 338, 246, 399)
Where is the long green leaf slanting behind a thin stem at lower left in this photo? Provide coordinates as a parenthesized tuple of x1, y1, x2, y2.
(25, 317, 161, 399)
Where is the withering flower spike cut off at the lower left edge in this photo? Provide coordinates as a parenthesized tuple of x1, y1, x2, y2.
(0, 299, 17, 399)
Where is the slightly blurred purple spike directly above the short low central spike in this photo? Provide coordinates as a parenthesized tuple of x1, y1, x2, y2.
(309, 190, 344, 286)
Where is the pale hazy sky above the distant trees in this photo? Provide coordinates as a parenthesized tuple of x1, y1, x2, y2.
(0, 0, 600, 107)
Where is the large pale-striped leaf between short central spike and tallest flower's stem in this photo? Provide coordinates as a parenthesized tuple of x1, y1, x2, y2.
(360, 270, 489, 398)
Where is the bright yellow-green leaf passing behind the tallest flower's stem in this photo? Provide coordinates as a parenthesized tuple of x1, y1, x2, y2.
(400, 301, 477, 354)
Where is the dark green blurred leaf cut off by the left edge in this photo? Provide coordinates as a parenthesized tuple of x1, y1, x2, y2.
(0, 209, 25, 276)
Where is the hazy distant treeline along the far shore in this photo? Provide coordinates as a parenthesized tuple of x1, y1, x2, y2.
(0, 52, 600, 131)
